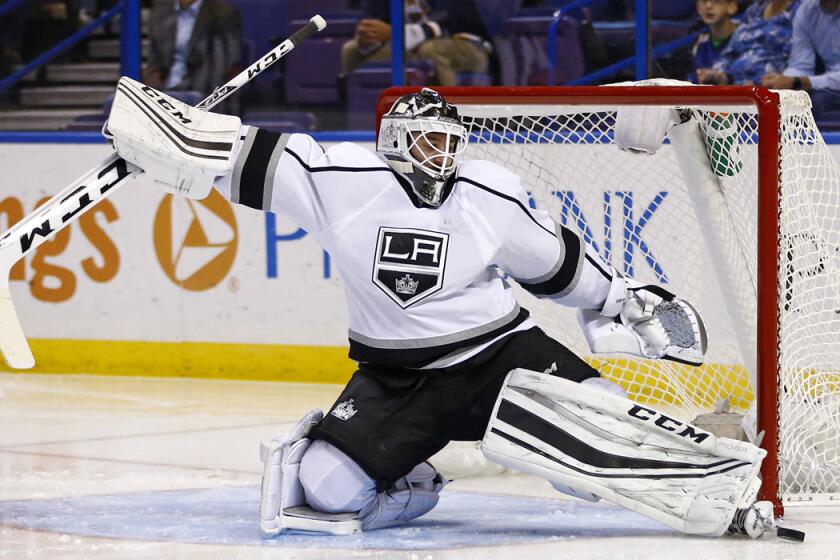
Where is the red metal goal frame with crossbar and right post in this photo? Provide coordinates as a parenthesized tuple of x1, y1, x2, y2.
(376, 85, 840, 513)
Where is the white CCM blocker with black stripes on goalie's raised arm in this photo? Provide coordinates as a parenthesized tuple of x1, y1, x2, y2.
(106, 77, 242, 199)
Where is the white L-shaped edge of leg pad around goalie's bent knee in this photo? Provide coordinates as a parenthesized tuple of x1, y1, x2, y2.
(260, 410, 361, 537)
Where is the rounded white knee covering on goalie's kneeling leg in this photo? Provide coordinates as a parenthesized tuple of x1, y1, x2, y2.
(299, 440, 376, 513)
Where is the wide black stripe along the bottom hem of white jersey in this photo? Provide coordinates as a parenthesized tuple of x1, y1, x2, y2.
(349, 308, 529, 369)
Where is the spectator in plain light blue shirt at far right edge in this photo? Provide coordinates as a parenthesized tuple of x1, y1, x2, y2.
(761, 0, 840, 119)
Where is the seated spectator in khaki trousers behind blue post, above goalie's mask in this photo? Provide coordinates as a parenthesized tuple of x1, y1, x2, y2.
(341, 0, 498, 86)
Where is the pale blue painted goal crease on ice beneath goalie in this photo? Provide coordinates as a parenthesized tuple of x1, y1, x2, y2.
(0, 486, 674, 550)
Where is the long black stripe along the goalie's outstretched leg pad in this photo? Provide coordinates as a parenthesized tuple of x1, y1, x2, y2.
(497, 399, 735, 471)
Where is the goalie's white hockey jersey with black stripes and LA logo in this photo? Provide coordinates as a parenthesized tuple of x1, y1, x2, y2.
(217, 128, 613, 368)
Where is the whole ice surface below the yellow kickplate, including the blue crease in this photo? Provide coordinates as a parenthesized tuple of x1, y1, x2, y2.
(0, 374, 840, 560)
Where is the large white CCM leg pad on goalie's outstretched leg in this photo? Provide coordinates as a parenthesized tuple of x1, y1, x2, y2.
(482, 369, 766, 536)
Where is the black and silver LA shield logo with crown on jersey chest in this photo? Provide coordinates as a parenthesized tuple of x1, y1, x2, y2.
(373, 227, 449, 309)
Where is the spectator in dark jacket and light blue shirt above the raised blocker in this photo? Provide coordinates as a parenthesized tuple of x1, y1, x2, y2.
(143, 0, 242, 94)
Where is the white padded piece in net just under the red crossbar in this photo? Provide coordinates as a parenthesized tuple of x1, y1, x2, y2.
(615, 105, 679, 155)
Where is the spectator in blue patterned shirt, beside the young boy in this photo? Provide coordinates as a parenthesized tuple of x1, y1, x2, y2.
(697, 0, 801, 85)
